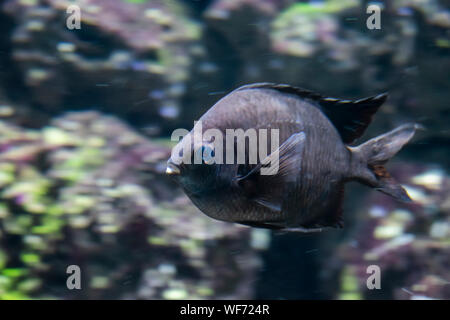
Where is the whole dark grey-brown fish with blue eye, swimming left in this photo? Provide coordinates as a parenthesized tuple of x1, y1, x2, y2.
(166, 83, 418, 233)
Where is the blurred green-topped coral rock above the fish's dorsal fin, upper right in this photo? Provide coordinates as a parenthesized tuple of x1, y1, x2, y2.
(270, 0, 448, 96)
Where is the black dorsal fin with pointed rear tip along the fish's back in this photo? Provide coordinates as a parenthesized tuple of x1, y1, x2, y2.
(237, 83, 388, 143)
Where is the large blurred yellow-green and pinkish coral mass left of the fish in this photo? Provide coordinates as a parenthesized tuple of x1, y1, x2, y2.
(0, 112, 261, 299)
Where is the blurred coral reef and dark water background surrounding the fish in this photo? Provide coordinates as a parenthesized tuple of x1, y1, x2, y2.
(0, 0, 450, 299)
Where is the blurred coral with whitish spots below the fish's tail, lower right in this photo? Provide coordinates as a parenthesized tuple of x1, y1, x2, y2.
(325, 165, 450, 299)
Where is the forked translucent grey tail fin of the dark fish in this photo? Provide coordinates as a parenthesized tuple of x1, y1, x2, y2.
(350, 123, 421, 202)
